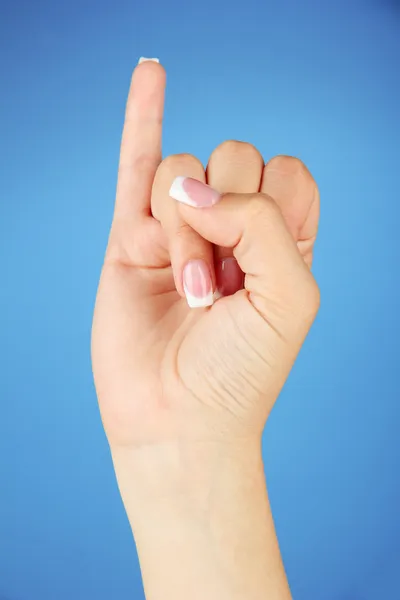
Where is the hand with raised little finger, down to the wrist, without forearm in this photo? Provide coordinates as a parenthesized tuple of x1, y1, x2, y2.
(93, 62, 318, 454)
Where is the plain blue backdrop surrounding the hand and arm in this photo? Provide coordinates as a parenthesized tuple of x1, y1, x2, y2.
(0, 0, 400, 600)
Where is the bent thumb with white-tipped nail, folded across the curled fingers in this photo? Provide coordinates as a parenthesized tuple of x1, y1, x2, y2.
(170, 177, 319, 338)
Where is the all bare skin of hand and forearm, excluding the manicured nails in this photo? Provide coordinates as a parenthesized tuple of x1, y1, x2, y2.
(92, 62, 319, 600)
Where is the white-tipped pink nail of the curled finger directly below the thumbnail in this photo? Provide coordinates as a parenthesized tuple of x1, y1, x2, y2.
(183, 260, 213, 308)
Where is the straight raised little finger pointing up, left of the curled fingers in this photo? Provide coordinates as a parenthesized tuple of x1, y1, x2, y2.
(115, 59, 166, 217)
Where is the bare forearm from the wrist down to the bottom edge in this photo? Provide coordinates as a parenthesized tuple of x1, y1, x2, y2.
(113, 440, 291, 600)
